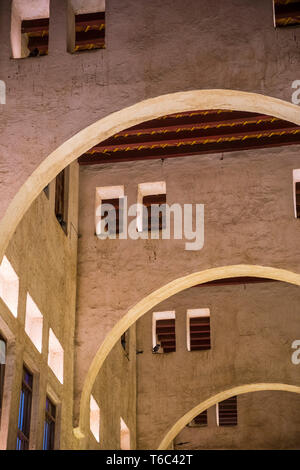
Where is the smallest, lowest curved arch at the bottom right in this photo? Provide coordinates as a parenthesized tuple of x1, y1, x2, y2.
(158, 383, 300, 450)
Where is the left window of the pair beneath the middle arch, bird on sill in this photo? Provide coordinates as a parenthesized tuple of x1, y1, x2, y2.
(152, 311, 176, 354)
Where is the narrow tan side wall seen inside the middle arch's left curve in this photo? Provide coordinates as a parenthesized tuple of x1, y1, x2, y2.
(88, 325, 137, 450)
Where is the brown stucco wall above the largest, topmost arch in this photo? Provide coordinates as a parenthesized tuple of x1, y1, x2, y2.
(0, 0, 299, 250)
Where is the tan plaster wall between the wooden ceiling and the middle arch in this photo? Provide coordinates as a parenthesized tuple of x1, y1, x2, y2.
(76, 146, 300, 424)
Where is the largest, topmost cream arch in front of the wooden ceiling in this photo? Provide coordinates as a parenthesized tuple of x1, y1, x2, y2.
(0, 89, 300, 260)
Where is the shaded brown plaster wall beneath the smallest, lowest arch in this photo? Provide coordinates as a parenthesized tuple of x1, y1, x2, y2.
(174, 392, 300, 450)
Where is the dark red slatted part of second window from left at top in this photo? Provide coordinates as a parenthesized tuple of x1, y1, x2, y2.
(74, 11, 105, 52)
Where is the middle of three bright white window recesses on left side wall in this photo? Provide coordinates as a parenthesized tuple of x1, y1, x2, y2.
(25, 293, 43, 352)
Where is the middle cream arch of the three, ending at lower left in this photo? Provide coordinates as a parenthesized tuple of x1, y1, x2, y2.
(74, 264, 300, 439)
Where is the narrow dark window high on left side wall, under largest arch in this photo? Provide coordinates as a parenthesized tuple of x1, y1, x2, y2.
(55, 168, 69, 234)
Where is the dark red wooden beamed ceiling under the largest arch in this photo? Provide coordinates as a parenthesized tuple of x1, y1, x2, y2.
(78, 110, 300, 165)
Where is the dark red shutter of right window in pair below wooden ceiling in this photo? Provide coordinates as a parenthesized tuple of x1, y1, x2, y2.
(143, 194, 167, 232)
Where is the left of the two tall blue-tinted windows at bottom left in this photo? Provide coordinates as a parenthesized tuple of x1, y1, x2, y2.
(17, 366, 33, 450)
